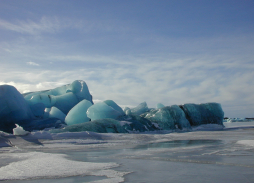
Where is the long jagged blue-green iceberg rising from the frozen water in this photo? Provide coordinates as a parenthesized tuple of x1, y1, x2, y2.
(0, 80, 224, 133)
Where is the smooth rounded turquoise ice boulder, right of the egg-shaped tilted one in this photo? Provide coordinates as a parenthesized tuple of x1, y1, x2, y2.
(86, 102, 122, 121)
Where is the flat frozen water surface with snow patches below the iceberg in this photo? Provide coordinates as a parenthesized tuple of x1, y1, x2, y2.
(0, 122, 254, 183)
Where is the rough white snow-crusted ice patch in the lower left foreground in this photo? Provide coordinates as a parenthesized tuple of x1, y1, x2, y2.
(0, 152, 129, 183)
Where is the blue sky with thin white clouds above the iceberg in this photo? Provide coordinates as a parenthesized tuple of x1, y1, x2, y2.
(0, 0, 254, 117)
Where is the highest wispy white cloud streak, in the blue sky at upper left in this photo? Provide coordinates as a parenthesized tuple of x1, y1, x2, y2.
(0, 16, 130, 35)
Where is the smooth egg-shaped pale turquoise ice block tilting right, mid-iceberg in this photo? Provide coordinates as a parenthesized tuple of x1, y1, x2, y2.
(65, 99, 92, 125)
